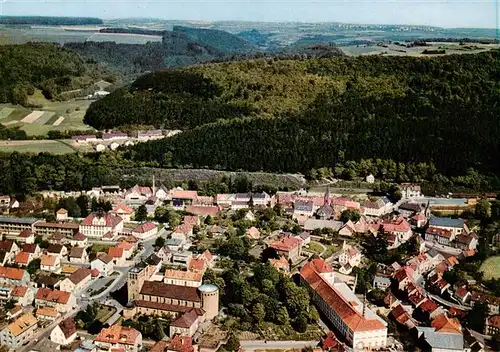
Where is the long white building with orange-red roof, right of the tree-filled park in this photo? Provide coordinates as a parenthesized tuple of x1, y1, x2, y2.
(300, 259, 387, 351)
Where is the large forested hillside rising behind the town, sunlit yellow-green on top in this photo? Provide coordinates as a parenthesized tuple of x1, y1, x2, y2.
(115, 51, 500, 174)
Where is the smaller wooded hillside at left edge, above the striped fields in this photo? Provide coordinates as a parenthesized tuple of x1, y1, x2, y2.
(0, 44, 110, 105)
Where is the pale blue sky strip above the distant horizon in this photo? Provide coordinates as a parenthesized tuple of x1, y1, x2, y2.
(0, 0, 500, 28)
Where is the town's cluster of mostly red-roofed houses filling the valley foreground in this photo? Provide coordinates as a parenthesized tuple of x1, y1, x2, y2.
(0, 180, 500, 352)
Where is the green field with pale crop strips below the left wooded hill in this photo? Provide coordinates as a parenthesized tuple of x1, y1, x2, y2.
(0, 96, 92, 136)
